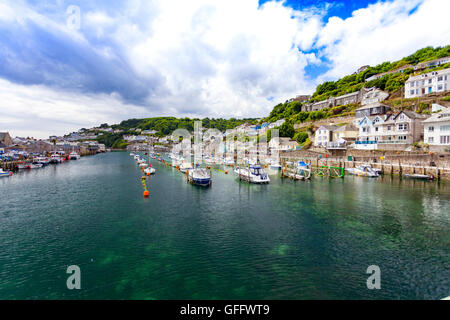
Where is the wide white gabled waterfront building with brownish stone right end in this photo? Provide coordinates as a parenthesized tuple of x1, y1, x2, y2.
(355, 110, 425, 150)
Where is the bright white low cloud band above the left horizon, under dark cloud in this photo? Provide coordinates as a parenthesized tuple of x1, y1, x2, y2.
(0, 79, 151, 138)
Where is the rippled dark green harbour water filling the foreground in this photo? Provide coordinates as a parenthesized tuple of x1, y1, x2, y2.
(0, 153, 450, 299)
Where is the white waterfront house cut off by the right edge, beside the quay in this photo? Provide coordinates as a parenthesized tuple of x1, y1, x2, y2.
(423, 108, 450, 150)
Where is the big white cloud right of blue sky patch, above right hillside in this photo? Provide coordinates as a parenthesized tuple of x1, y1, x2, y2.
(317, 0, 450, 80)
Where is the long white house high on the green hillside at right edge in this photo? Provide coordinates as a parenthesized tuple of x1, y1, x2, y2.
(405, 68, 450, 98)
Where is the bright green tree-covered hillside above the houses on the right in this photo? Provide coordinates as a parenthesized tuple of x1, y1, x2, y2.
(262, 45, 450, 123)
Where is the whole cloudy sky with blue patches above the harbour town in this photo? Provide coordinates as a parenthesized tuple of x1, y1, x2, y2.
(0, 0, 450, 138)
